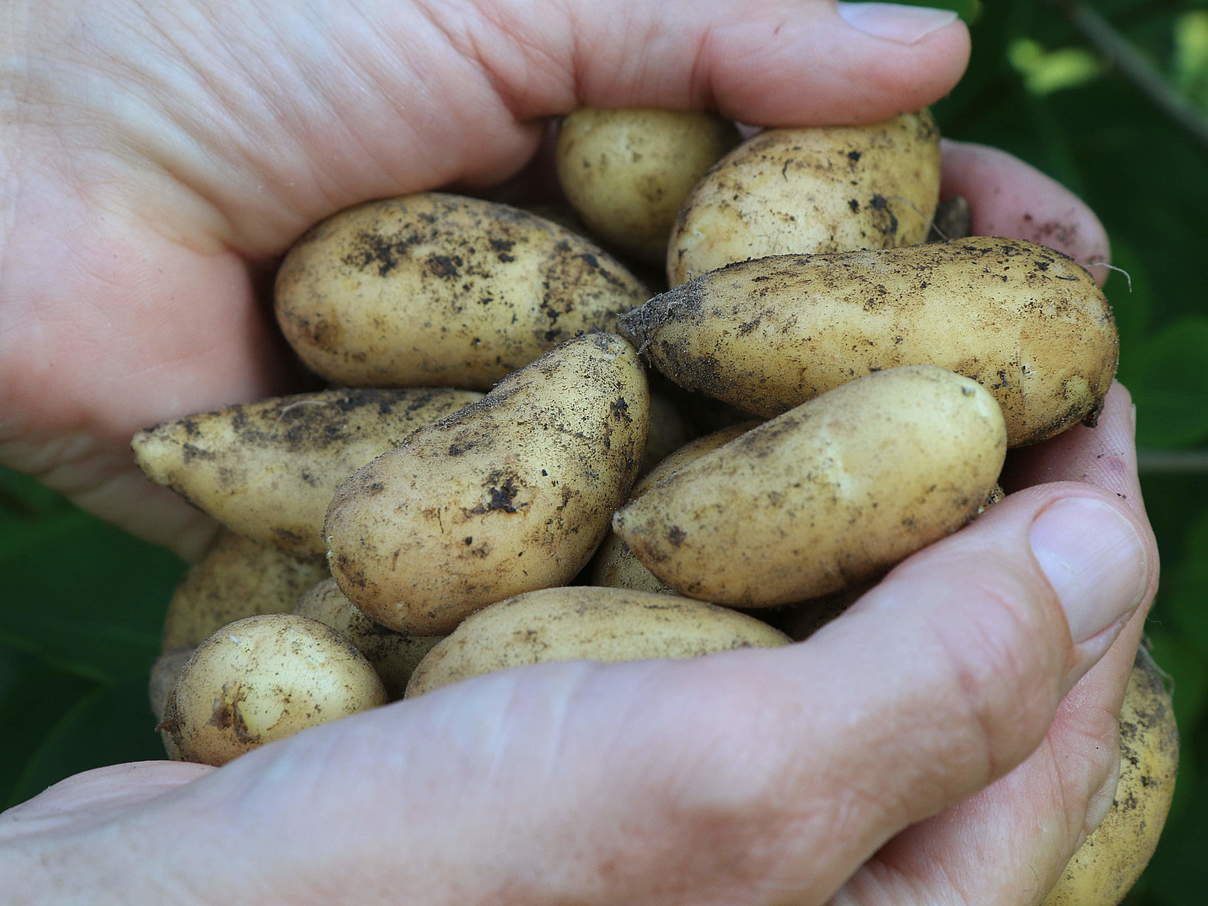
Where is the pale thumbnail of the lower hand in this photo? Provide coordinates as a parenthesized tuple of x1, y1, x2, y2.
(1028, 496, 1149, 644)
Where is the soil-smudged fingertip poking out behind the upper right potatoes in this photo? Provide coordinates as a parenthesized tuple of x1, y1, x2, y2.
(940, 139, 1111, 285)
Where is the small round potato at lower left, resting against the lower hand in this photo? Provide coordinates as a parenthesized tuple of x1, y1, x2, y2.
(159, 614, 387, 765)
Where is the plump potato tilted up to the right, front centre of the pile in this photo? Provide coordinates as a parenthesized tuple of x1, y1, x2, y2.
(325, 333, 649, 635)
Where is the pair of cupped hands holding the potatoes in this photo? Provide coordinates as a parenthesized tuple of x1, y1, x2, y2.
(0, 0, 1157, 906)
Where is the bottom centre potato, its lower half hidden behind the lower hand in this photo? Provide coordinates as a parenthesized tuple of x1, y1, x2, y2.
(407, 587, 789, 698)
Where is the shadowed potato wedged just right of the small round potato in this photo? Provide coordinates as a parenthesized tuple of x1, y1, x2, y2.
(294, 577, 445, 701)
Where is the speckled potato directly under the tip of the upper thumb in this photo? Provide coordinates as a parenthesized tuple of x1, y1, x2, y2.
(667, 110, 940, 286)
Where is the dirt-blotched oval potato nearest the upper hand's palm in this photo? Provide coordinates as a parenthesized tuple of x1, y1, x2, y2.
(277, 192, 647, 390)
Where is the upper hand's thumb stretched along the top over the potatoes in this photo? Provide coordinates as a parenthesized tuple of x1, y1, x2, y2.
(475, 0, 969, 126)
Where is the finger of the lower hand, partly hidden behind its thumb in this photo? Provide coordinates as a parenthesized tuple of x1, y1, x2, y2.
(836, 396, 1152, 906)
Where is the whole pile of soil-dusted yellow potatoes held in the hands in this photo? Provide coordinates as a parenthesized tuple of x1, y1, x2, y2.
(133, 110, 1171, 903)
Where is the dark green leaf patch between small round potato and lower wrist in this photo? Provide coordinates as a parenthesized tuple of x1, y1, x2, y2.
(12, 675, 165, 802)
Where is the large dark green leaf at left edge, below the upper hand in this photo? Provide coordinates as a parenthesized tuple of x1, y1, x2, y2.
(0, 474, 185, 683)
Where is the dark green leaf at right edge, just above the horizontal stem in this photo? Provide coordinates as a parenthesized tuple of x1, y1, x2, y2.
(1120, 315, 1208, 447)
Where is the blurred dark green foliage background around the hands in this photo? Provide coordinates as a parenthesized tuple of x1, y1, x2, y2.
(0, 0, 1208, 906)
